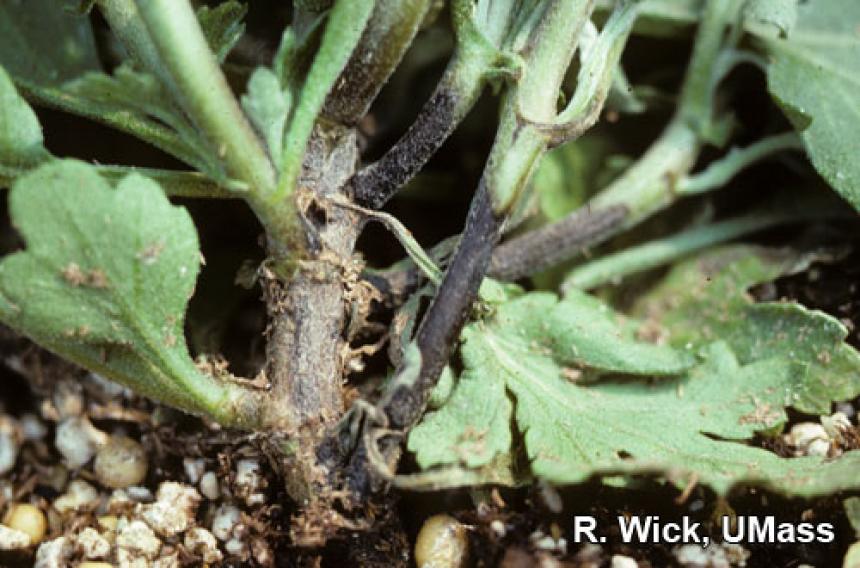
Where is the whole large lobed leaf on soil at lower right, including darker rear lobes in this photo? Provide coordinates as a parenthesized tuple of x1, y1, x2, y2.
(409, 248, 860, 495)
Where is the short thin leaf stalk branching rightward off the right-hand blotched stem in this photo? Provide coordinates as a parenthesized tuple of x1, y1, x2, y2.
(677, 132, 803, 195)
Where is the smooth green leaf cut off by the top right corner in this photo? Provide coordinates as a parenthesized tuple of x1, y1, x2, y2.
(760, 0, 860, 209)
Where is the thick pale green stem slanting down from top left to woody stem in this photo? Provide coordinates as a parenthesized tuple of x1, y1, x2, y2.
(132, 0, 275, 199)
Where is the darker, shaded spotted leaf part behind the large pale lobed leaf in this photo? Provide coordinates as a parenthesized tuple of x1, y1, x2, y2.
(634, 245, 860, 414)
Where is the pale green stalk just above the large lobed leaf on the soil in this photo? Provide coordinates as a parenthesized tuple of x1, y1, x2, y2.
(561, 212, 809, 292)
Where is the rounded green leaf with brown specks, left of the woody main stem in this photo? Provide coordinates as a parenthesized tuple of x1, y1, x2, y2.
(0, 161, 252, 422)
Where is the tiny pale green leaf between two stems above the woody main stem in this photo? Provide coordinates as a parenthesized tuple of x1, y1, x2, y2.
(242, 67, 291, 168)
